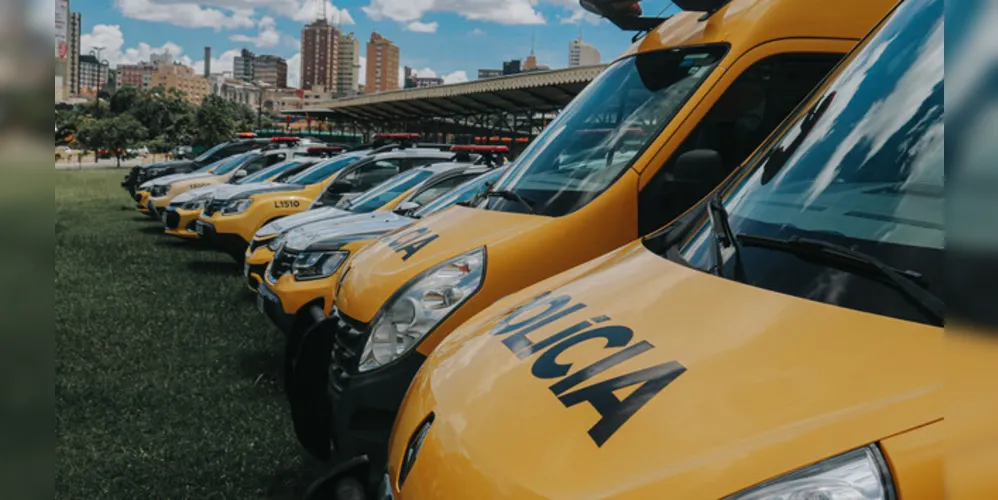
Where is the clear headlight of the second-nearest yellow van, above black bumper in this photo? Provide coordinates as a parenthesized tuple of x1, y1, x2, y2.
(359, 247, 485, 372)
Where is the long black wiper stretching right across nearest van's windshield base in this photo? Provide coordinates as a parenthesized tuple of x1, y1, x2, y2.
(738, 234, 946, 326)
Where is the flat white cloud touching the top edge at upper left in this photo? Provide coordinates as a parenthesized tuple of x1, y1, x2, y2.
(115, 0, 256, 31)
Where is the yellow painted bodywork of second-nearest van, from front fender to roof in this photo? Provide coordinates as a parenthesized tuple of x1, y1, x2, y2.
(337, 0, 896, 368)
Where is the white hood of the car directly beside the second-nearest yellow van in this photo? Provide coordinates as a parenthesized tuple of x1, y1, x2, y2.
(285, 212, 416, 252)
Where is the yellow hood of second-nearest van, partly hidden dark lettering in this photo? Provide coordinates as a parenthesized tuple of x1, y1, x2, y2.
(337, 206, 551, 322)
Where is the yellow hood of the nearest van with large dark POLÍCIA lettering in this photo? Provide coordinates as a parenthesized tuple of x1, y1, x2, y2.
(394, 243, 945, 499)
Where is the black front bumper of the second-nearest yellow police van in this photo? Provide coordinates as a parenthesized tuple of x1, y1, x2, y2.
(285, 306, 426, 474)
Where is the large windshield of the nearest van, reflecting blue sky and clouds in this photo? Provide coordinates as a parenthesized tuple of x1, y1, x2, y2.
(668, 0, 945, 324)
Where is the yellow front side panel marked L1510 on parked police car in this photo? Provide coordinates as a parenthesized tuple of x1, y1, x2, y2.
(201, 184, 324, 244)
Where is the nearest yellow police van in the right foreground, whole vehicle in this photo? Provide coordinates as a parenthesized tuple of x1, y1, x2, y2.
(376, 0, 944, 500)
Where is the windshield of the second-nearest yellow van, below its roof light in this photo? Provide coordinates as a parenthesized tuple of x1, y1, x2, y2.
(481, 45, 727, 216)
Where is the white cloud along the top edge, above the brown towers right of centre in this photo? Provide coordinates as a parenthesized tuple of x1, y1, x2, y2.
(361, 0, 545, 25)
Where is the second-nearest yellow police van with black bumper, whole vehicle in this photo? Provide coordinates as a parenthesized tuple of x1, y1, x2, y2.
(288, 0, 895, 484)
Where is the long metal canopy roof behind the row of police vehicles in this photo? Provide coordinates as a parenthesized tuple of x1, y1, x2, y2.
(284, 64, 606, 121)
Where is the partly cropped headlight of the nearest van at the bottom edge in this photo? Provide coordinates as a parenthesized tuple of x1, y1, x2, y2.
(724, 446, 896, 500)
